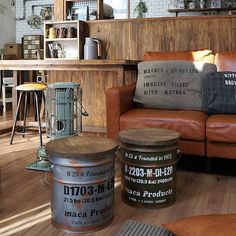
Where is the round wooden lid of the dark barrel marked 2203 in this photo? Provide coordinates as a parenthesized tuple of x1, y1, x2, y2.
(119, 128, 180, 146)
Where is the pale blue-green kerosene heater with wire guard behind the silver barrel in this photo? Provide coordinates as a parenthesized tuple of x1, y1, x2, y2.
(26, 82, 88, 171)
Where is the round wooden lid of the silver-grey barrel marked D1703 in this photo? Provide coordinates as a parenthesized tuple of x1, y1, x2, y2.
(45, 136, 117, 164)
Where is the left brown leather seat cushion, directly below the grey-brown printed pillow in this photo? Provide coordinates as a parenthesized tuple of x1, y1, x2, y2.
(120, 108, 207, 141)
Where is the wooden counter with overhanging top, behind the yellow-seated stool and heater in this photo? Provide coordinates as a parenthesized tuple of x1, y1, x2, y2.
(0, 60, 139, 132)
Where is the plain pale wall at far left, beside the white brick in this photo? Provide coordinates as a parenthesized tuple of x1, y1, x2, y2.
(0, 0, 16, 53)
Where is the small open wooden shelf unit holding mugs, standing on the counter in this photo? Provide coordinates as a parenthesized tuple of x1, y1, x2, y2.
(44, 21, 84, 60)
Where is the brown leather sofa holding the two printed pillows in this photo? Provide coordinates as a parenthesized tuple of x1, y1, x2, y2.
(106, 50, 236, 158)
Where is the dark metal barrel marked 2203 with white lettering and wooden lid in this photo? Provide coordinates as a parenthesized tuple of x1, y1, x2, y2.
(118, 128, 180, 208)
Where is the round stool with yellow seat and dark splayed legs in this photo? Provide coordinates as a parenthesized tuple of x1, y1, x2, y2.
(10, 83, 47, 146)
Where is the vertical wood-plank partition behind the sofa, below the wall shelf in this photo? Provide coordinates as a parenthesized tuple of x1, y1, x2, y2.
(86, 15, 236, 60)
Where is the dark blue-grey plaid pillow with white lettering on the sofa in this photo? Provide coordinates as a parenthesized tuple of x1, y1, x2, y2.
(202, 72, 236, 115)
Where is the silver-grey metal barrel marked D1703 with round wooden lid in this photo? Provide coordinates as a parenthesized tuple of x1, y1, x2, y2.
(46, 136, 117, 233)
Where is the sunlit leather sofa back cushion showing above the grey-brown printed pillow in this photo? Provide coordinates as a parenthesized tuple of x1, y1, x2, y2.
(144, 50, 215, 63)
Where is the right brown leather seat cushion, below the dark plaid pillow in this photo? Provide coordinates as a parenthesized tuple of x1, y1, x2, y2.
(206, 114, 236, 143)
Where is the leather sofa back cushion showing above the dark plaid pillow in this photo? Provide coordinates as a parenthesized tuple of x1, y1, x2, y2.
(215, 51, 236, 72)
